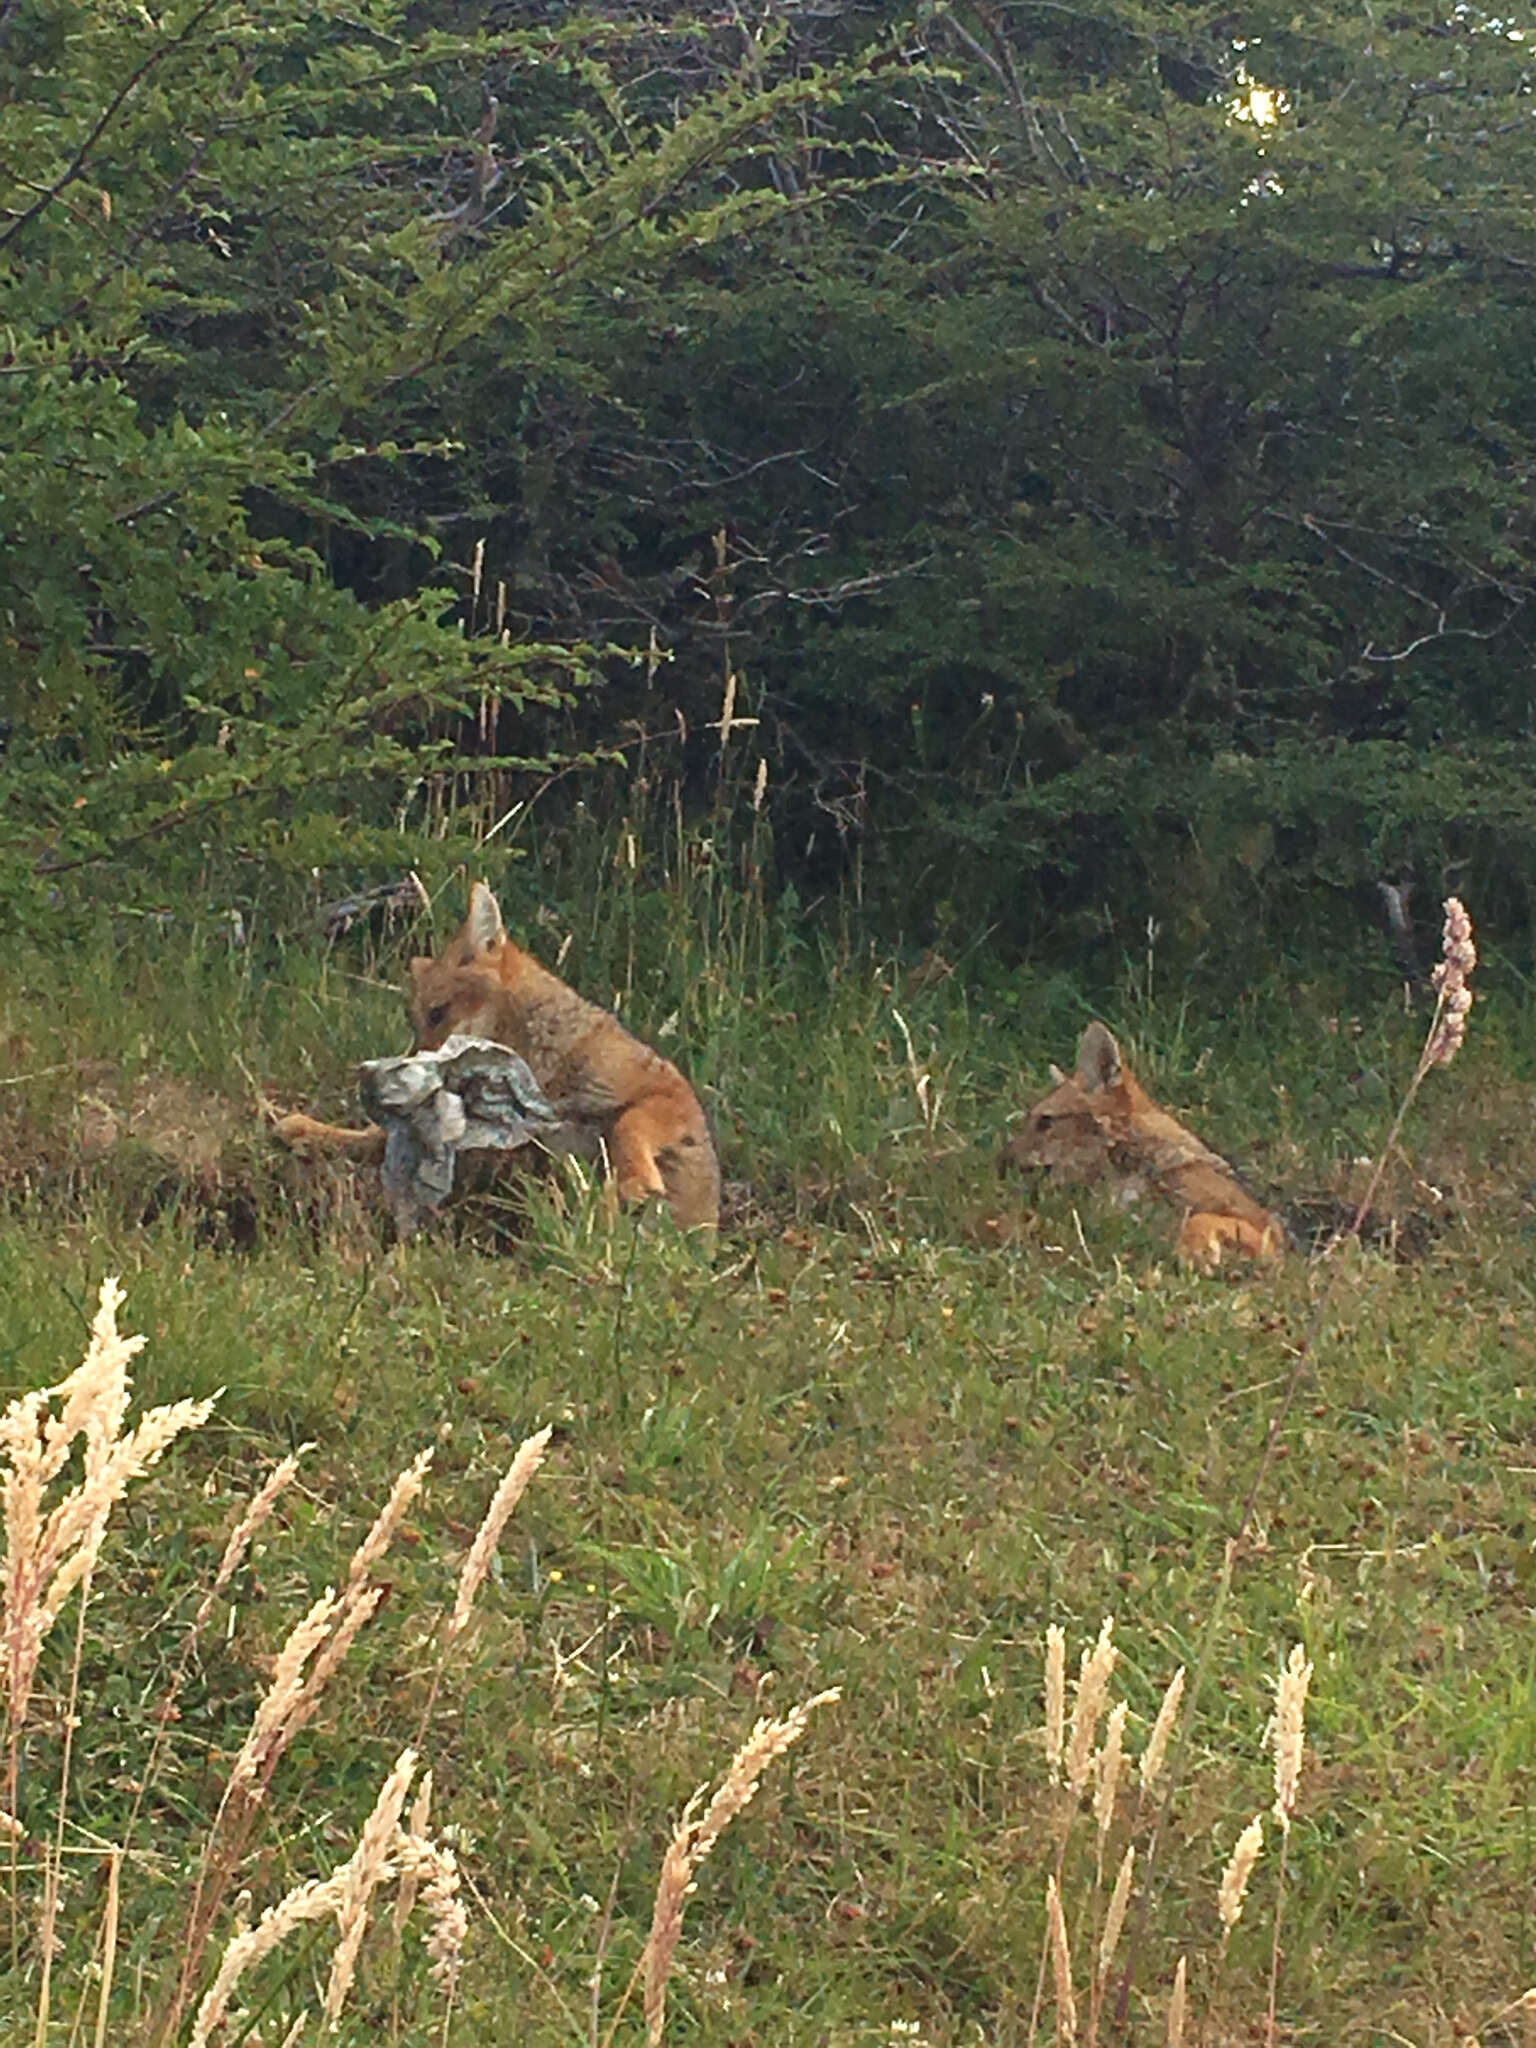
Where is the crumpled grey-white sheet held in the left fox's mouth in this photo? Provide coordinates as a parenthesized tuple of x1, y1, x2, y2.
(358, 1032, 592, 1235)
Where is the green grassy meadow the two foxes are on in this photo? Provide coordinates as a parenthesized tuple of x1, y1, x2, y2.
(0, 854, 1536, 2048)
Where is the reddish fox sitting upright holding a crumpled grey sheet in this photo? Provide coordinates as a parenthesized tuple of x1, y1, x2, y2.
(274, 883, 721, 1233)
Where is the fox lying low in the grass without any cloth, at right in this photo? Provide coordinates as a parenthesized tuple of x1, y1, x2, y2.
(997, 1022, 1286, 1272)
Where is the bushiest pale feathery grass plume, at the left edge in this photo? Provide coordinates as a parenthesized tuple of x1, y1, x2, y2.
(0, 1278, 217, 1737)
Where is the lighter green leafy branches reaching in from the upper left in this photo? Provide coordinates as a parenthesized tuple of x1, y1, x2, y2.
(0, 0, 901, 925)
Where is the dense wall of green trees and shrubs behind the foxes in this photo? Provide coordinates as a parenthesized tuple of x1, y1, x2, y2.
(12, 0, 1536, 971)
